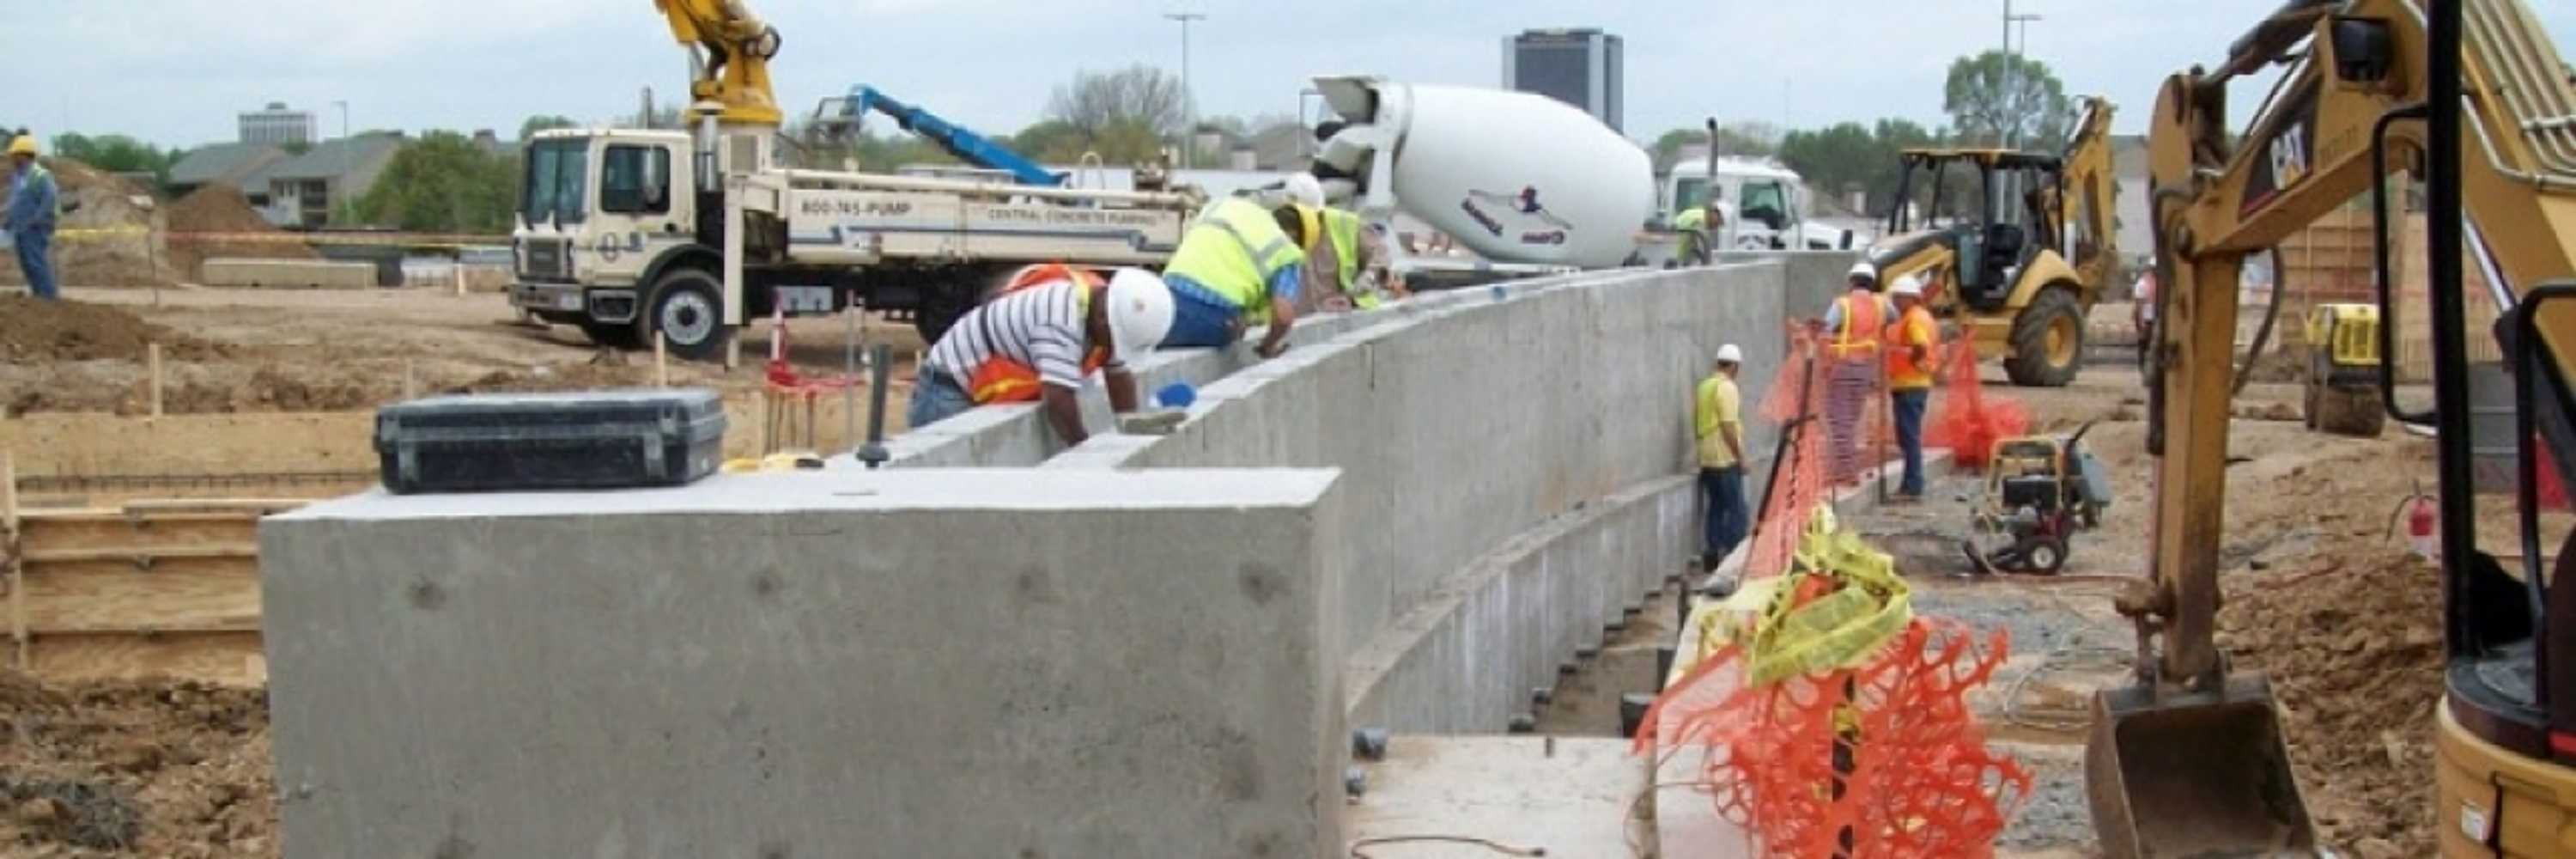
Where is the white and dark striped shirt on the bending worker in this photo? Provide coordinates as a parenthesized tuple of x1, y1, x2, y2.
(927, 281, 1090, 389)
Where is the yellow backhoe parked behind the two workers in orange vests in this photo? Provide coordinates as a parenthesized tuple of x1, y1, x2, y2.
(1870, 95, 2120, 387)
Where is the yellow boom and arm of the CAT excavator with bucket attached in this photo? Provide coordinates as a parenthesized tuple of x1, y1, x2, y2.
(2087, 0, 2576, 856)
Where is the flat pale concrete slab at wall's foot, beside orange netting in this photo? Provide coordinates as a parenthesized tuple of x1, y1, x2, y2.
(1350, 735, 1654, 859)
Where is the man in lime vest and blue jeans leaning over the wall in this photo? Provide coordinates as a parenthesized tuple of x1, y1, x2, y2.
(1162, 173, 1324, 358)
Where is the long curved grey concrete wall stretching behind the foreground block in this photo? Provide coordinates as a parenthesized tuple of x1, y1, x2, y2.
(1048, 263, 1785, 730)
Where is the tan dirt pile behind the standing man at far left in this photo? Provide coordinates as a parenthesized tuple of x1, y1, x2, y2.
(0, 157, 175, 286)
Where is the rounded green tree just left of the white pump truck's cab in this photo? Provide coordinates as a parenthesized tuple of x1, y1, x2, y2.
(353, 131, 518, 232)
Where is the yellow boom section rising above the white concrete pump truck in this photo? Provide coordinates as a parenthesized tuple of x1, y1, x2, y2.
(652, 0, 781, 129)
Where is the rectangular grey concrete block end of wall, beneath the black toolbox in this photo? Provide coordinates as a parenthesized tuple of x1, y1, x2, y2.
(260, 470, 1350, 856)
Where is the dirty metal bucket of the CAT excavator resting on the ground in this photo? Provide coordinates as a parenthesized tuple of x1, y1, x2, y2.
(2084, 676, 2316, 859)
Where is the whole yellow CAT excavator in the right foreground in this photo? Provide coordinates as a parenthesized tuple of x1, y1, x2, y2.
(2087, 0, 2576, 856)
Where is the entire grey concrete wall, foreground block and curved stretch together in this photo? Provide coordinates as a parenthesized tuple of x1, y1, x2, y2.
(260, 255, 1850, 856)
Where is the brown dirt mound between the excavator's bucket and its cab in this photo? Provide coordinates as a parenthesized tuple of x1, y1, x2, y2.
(2218, 547, 2442, 859)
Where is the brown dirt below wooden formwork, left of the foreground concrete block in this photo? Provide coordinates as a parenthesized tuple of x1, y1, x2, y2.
(0, 673, 278, 856)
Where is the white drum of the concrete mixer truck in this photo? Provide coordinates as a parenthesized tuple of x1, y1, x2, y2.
(1314, 75, 1654, 281)
